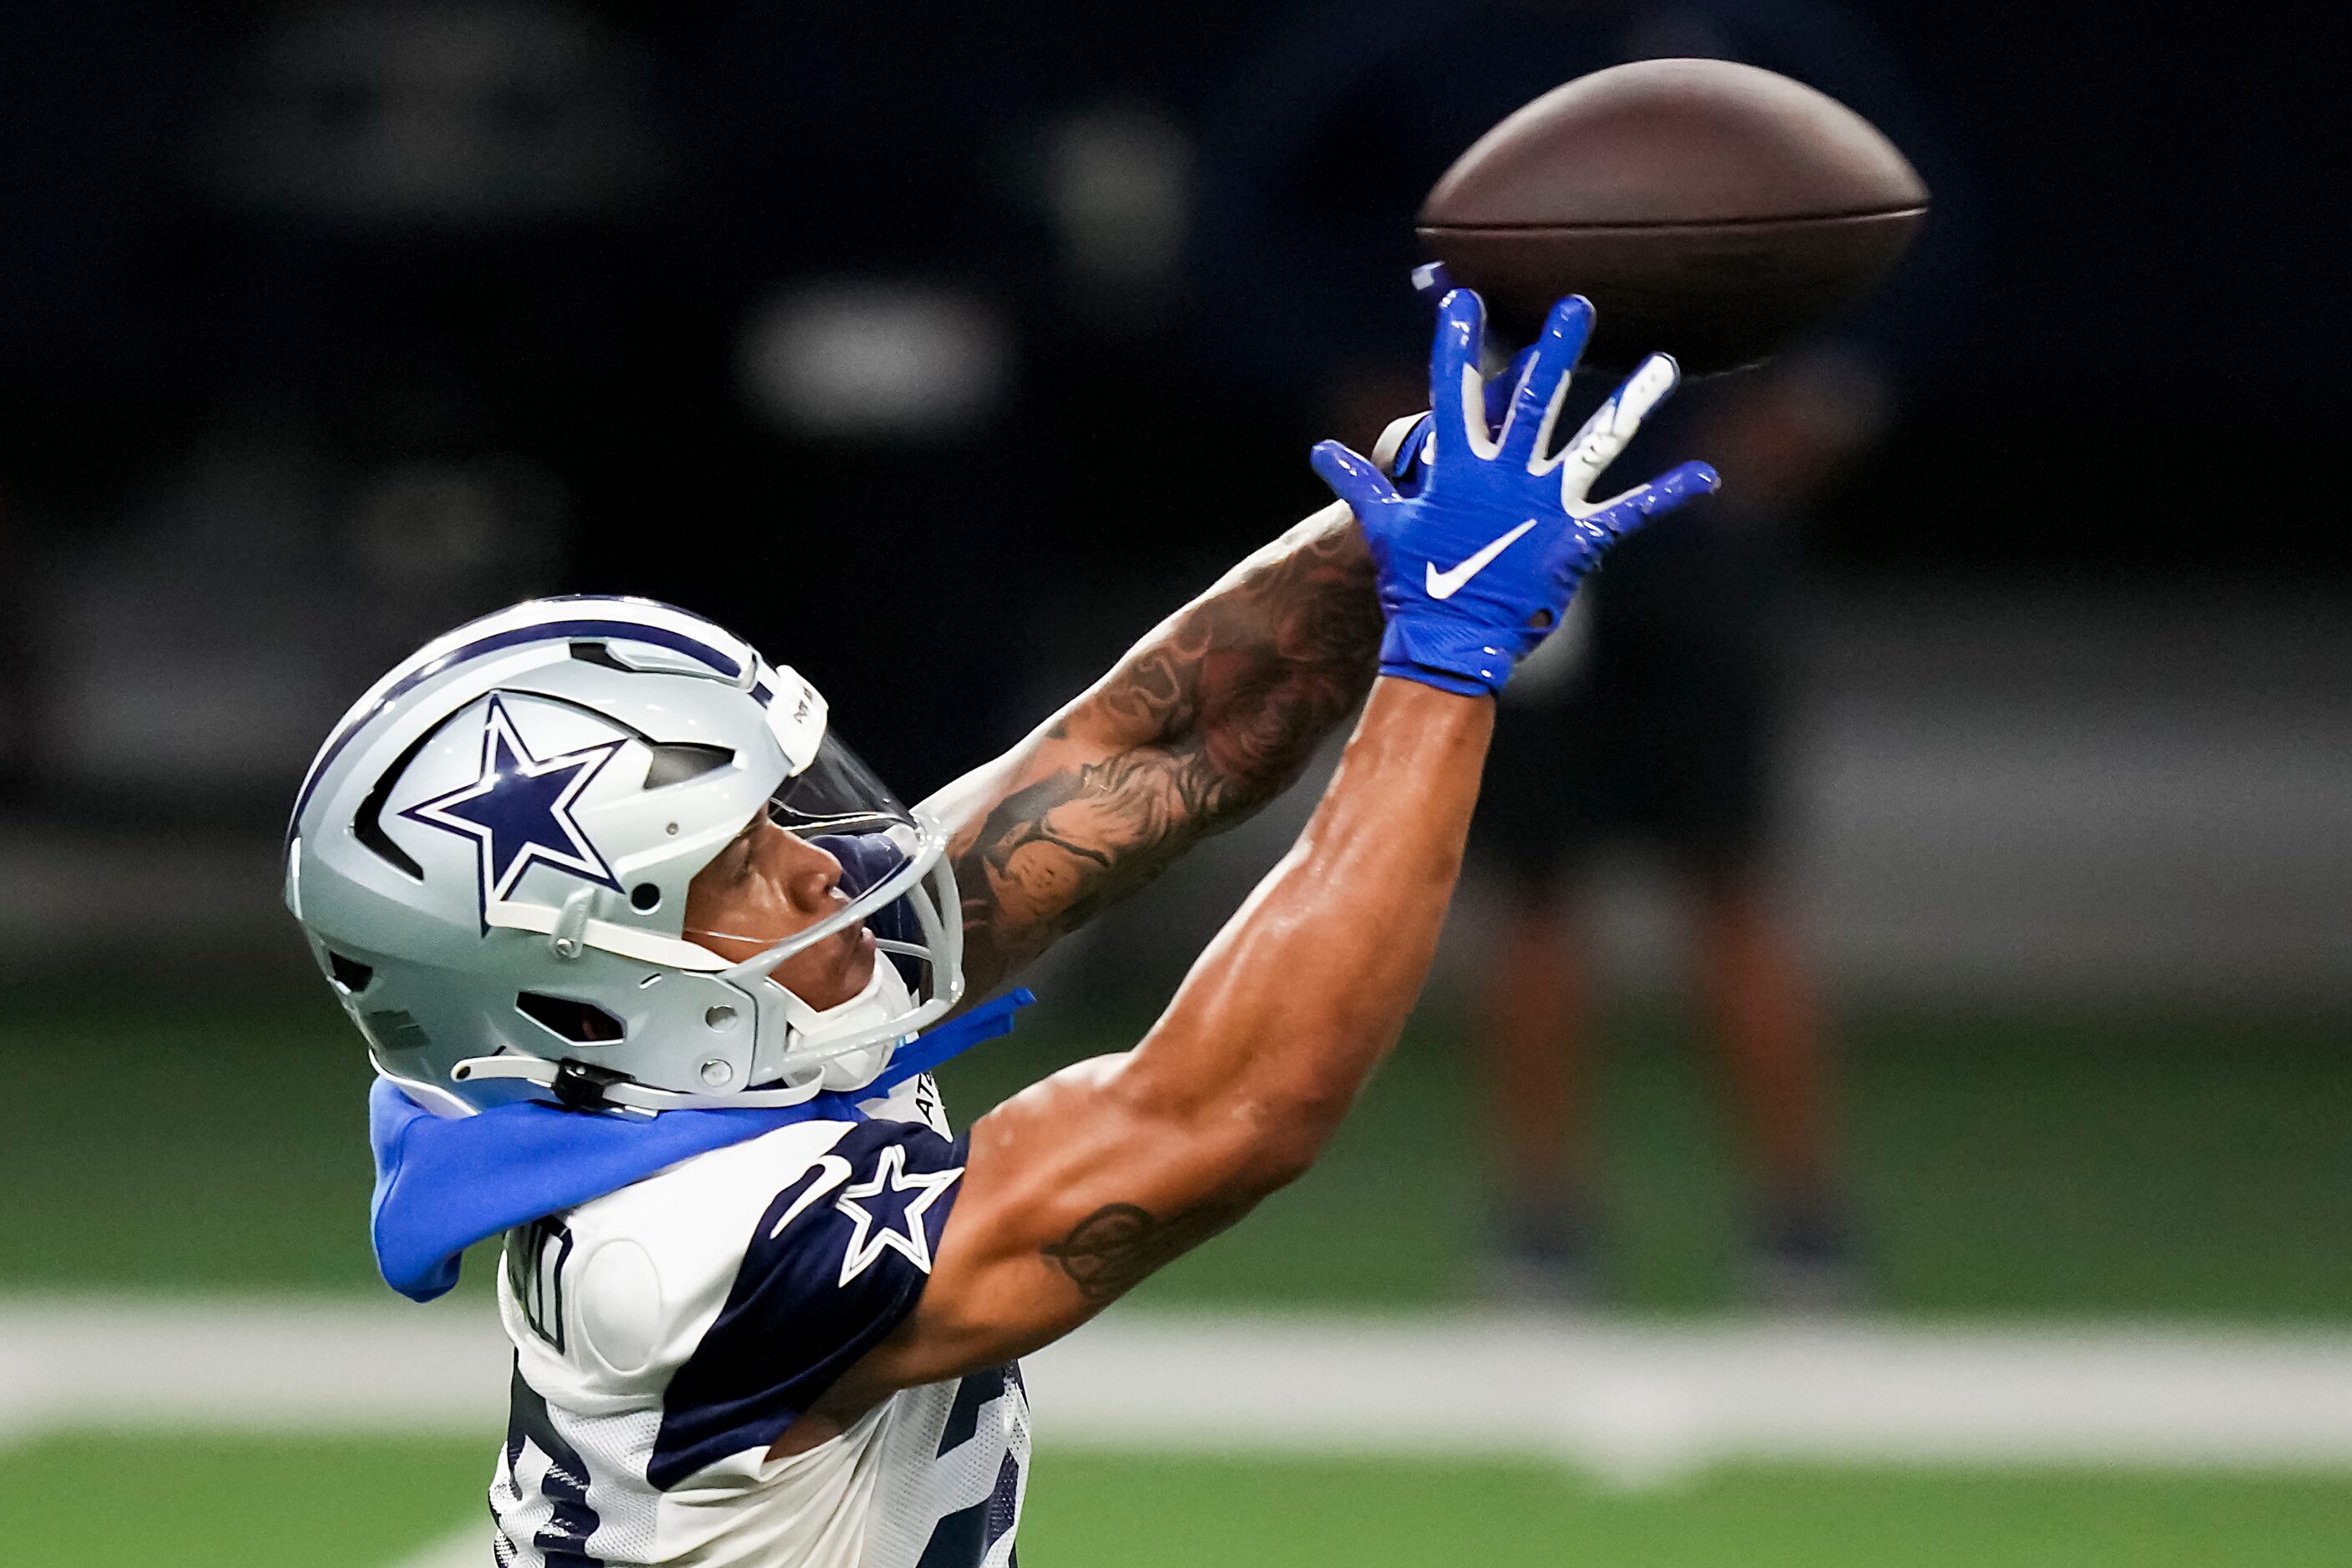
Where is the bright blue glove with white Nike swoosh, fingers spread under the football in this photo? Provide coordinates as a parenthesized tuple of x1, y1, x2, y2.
(1313, 289, 1717, 695)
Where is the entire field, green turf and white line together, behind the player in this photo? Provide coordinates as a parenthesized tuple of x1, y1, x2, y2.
(0, 985, 2352, 1568)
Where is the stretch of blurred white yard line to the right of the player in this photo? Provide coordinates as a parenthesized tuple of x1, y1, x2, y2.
(1030, 1319, 2352, 1481)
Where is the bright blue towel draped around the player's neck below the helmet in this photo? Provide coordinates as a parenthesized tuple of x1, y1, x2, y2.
(367, 989, 1034, 1302)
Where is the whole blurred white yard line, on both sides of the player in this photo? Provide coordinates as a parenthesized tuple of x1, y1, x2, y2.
(0, 1300, 2352, 1481)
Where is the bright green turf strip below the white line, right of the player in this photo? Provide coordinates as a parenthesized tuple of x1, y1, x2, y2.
(1044, 1455, 2352, 1568)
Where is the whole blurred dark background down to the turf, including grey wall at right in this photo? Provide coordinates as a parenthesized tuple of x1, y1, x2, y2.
(0, 0, 2352, 1034)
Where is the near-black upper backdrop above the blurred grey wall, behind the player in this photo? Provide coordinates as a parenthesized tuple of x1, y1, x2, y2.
(0, 0, 2352, 821)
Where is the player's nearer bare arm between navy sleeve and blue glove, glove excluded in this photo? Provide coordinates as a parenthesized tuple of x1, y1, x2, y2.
(865, 680, 1494, 1382)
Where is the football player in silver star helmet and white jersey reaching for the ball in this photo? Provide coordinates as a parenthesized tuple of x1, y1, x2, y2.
(287, 291, 1715, 1568)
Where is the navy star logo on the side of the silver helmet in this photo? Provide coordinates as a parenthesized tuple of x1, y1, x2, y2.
(400, 694, 625, 912)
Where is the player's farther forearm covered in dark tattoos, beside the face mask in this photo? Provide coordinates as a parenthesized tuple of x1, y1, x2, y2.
(924, 505, 1381, 997)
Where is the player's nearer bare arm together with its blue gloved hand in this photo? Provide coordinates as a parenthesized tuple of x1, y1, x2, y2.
(783, 296, 1715, 1450)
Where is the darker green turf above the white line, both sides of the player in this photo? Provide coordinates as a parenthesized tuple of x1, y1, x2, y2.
(0, 988, 2352, 1321)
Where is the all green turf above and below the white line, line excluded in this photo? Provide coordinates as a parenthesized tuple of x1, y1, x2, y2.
(0, 985, 2352, 1568)
